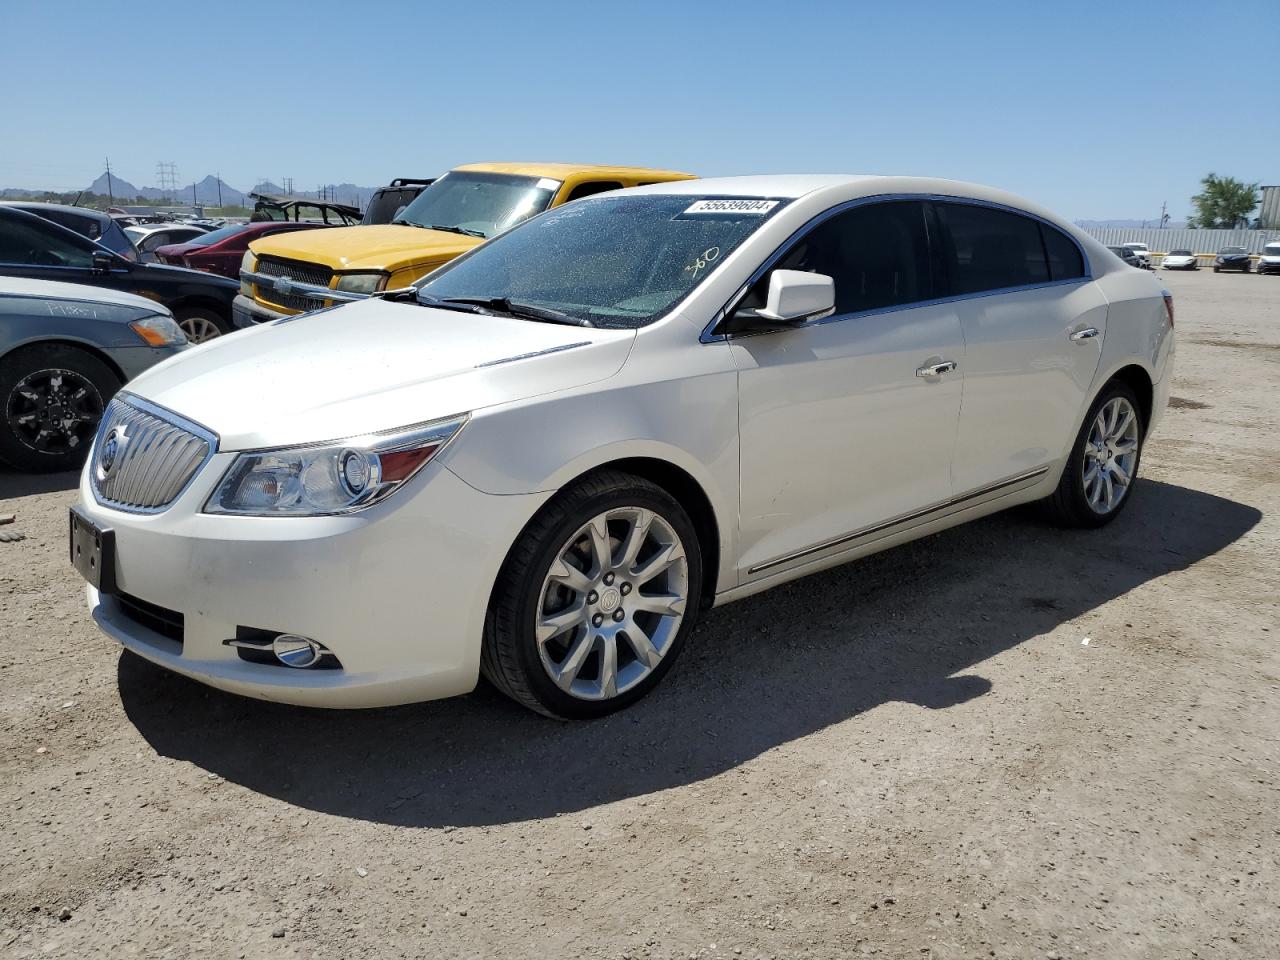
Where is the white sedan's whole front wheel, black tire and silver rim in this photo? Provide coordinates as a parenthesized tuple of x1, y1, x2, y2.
(481, 472, 703, 719)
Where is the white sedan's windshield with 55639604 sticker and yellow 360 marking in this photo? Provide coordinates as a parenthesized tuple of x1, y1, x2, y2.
(417, 195, 787, 328)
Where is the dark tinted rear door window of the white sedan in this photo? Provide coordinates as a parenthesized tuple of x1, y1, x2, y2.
(937, 204, 1048, 293)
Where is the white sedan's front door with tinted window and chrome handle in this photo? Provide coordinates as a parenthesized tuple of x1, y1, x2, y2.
(730, 200, 964, 581)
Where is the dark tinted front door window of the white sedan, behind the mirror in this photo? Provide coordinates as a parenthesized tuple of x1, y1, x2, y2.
(740, 201, 934, 315)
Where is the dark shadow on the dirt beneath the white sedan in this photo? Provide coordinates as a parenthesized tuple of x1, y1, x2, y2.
(118, 480, 1262, 826)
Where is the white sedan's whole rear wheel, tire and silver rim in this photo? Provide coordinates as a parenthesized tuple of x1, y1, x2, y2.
(1044, 380, 1146, 527)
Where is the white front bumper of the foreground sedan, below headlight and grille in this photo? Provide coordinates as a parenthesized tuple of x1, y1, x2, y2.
(79, 453, 549, 708)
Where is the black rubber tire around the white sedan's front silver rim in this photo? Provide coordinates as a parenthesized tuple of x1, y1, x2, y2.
(480, 471, 703, 719)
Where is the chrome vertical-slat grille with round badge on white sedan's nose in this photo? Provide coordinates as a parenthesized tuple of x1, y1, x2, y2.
(90, 397, 215, 513)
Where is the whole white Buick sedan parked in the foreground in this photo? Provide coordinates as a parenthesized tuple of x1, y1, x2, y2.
(72, 175, 1174, 718)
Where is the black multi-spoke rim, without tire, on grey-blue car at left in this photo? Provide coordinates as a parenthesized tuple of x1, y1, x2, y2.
(5, 369, 105, 454)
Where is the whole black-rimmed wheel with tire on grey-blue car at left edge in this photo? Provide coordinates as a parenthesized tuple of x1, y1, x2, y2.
(0, 344, 120, 472)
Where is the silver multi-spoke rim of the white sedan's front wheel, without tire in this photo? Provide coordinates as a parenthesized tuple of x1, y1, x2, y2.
(534, 507, 689, 700)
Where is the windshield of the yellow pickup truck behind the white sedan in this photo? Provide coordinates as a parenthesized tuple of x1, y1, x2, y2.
(396, 173, 561, 237)
